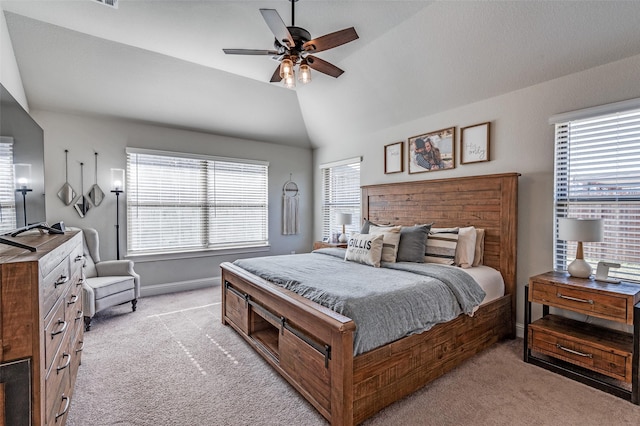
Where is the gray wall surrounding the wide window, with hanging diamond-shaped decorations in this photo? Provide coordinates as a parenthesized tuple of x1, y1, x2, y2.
(31, 109, 313, 296)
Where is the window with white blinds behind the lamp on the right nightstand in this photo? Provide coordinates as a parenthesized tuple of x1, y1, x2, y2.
(550, 100, 640, 281)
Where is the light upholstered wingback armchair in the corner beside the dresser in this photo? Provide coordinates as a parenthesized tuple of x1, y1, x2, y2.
(82, 228, 140, 331)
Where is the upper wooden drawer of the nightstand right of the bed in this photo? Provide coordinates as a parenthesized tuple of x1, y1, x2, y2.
(531, 281, 633, 323)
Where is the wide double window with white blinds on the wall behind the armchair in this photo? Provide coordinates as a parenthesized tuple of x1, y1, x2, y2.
(125, 148, 269, 254)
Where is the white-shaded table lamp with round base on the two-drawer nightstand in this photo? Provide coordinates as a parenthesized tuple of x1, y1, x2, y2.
(558, 218, 603, 278)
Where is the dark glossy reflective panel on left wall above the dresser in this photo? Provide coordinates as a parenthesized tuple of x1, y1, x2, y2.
(0, 84, 46, 233)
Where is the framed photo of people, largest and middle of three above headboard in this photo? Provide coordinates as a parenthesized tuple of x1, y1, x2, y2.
(408, 127, 456, 174)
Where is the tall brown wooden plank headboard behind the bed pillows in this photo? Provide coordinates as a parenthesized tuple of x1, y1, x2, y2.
(362, 173, 520, 318)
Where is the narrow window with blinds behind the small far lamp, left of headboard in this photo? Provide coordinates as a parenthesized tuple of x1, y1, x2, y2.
(320, 157, 361, 240)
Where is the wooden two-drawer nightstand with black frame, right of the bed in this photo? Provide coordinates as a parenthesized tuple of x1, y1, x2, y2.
(524, 272, 640, 404)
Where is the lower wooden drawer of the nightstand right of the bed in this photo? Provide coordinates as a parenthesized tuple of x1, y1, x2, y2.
(528, 315, 633, 383)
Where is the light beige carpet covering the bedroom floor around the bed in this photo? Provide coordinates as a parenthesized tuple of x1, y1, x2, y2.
(67, 287, 640, 426)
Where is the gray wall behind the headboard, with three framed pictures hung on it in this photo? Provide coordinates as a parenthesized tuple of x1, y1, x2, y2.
(314, 56, 640, 333)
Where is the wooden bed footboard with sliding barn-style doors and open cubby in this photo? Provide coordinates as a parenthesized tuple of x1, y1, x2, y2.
(221, 263, 355, 425)
